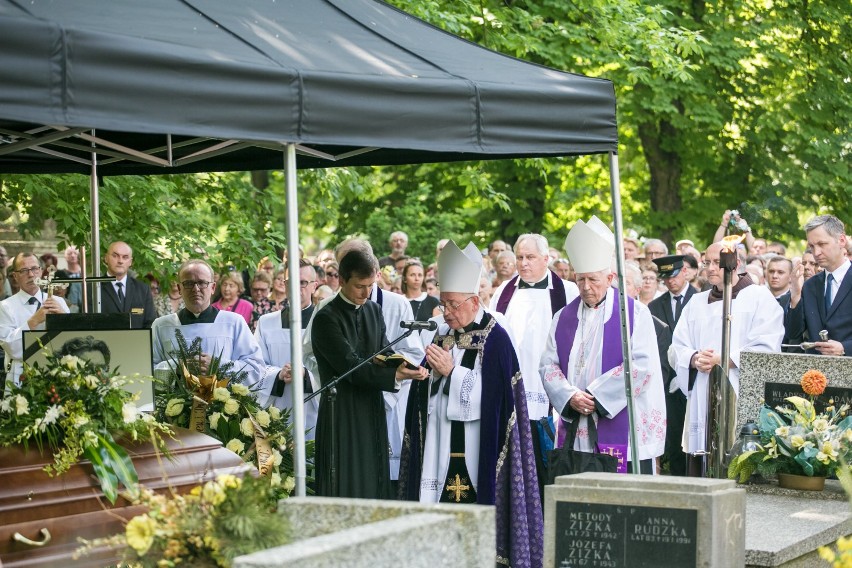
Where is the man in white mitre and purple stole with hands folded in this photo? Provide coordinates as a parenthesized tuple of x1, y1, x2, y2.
(540, 217, 666, 473)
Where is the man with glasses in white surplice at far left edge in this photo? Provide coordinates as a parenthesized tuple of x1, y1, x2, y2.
(0, 252, 69, 384)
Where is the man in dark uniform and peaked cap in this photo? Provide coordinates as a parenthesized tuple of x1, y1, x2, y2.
(648, 255, 698, 476)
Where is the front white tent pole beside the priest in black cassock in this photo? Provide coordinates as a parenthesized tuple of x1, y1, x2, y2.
(284, 144, 306, 497)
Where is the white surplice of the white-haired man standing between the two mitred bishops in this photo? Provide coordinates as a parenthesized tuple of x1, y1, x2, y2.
(490, 270, 579, 421)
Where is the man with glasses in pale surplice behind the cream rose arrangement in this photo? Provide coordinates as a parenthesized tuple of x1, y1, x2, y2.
(151, 259, 268, 390)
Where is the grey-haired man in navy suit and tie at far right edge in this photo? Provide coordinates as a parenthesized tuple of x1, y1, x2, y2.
(786, 215, 852, 356)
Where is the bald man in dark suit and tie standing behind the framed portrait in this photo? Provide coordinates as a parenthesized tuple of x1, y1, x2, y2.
(95, 241, 157, 329)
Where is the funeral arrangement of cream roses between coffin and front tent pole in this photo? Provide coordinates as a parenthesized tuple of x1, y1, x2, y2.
(156, 330, 295, 493)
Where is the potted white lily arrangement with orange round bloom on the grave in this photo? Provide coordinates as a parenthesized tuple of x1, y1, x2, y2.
(728, 370, 852, 490)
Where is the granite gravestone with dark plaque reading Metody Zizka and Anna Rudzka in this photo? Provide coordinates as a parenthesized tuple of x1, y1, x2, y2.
(544, 473, 745, 568)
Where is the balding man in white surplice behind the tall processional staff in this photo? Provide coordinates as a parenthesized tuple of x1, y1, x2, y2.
(669, 243, 784, 474)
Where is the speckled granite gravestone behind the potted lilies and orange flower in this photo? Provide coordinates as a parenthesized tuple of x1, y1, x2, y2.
(737, 351, 852, 431)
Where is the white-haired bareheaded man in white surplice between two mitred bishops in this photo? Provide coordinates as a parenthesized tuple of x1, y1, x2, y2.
(491, 233, 580, 487)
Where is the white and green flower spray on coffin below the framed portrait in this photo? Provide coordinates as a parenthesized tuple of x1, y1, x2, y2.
(0, 350, 173, 503)
